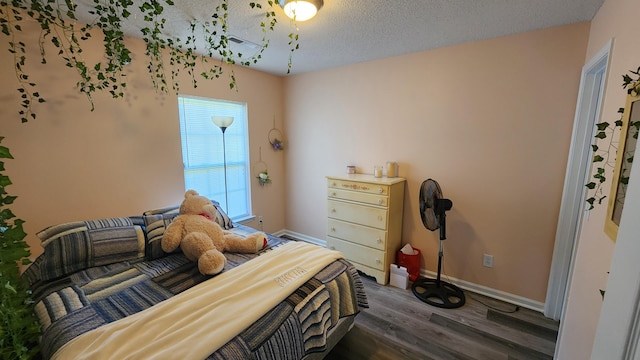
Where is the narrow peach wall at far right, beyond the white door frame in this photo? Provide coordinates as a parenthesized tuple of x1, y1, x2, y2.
(556, 0, 640, 360)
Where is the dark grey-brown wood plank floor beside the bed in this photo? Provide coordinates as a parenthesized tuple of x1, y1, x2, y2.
(326, 276, 558, 360)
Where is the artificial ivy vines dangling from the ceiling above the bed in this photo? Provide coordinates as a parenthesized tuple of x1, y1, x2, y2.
(0, 0, 299, 122)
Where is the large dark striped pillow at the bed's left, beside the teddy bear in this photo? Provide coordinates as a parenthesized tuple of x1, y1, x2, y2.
(36, 217, 145, 281)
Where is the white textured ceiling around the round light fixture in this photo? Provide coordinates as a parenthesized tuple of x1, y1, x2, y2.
(71, 0, 604, 75)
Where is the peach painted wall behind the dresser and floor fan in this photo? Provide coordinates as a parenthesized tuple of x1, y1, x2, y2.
(285, 23, 589, 302)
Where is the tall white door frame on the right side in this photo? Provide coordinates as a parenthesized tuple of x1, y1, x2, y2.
(544, 40, 613, 320)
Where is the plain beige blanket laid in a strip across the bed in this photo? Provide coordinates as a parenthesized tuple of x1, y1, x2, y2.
(53, 242, 342, 360)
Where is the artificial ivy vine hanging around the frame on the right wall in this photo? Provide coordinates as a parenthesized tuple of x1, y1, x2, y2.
(585, 67, 640, 210)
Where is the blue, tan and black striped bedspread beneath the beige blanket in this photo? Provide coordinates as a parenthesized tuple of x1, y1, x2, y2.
(27, 227, 368, 359)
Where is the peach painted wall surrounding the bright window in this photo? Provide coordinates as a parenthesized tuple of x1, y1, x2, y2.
(0, 15, 285, 255)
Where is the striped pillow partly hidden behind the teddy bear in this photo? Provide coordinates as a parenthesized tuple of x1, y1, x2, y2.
(142, 200, 234, 260)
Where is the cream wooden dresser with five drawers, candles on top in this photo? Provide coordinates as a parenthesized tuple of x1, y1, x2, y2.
(327, 174, 405, 285)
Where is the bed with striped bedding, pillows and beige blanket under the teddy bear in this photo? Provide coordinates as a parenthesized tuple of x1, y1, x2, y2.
(24, 204, 368, 360)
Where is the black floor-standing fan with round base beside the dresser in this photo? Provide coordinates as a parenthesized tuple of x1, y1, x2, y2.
(411, 179, 465, 309)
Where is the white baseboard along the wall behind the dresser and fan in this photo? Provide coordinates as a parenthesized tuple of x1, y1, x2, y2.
(273, 229, 544, 312)
